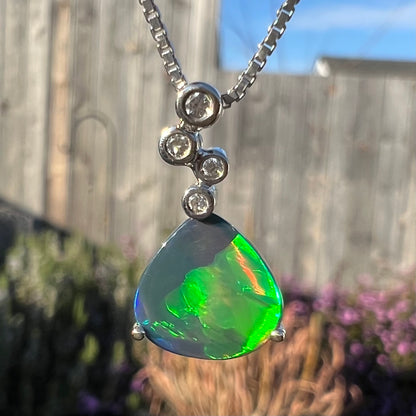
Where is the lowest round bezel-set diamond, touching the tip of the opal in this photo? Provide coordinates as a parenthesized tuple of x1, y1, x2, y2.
(182, 184, 215, 220)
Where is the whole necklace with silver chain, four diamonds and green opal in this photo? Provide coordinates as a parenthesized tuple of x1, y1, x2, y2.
(132, 0, 299, 360)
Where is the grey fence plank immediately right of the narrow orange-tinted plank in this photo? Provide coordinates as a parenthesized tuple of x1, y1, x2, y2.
(69, 0, 101, 235)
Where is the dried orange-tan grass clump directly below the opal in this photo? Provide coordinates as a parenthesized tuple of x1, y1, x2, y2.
(133, 311, 361, 416)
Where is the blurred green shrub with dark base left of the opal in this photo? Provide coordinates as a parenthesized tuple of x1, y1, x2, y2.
(0, 232, 142, 416)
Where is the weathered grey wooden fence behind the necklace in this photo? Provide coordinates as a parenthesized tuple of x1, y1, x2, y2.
(0, 0, 416, 285)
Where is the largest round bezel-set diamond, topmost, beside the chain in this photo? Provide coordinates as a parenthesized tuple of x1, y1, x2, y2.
(176, 82, 223, 129)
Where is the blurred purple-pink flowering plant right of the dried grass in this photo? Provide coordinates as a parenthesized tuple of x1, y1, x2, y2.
(313, 269, 416, 416)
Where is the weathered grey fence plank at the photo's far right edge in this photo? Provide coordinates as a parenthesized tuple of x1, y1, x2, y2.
(372, 79, 416, 272)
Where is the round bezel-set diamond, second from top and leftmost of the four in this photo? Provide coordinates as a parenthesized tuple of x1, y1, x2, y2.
(159, 127, 201, 165)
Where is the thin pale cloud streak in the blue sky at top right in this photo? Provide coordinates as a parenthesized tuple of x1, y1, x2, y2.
(292, 2, 416, 31)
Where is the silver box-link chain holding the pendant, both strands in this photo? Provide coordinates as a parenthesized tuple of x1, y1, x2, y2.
(139, 0, 300, 108)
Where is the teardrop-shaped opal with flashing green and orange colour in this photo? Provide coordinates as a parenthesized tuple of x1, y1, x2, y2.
(134, 215, 283, 360)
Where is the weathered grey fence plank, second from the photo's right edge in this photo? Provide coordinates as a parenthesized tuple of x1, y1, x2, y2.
(344, 75, 385, 282)
